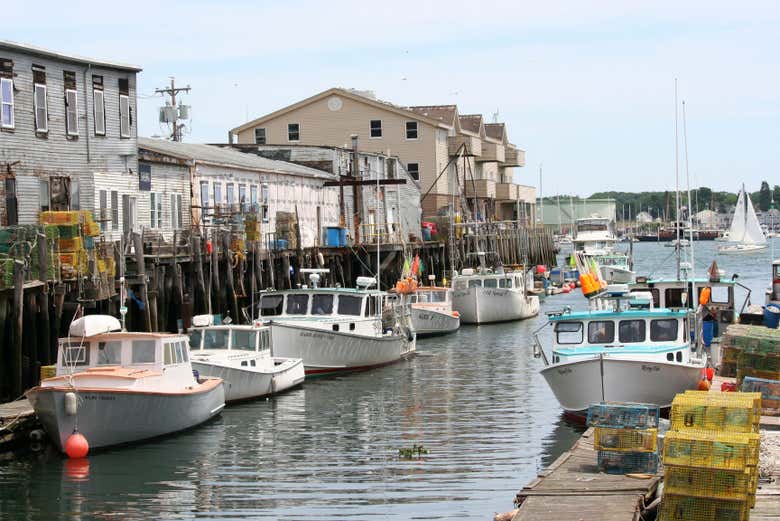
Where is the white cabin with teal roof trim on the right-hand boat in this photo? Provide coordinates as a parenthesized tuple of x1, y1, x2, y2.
(550, 310, 690, 364)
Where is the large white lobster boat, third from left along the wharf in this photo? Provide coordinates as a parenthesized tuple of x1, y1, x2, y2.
(260, 274, 416, 375)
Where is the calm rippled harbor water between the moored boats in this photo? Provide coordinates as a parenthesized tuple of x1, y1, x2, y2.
(0, 243, 772, 520)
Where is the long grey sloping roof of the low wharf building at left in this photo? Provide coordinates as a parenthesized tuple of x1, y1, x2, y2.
(138, 137, 334, 179)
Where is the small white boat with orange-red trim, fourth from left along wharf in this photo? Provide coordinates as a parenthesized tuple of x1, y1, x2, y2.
(405, 286, 460, 337)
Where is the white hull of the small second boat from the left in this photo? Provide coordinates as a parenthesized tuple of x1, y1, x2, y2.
(191, 358, 304, 403)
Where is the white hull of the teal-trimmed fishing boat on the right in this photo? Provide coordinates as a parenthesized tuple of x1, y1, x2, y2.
(541, 356, 704, 412)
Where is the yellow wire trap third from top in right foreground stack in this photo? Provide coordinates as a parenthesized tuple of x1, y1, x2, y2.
(664, 465, 755, 501)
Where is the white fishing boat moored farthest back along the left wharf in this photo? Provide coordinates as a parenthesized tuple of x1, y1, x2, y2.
(452, 268, 539, 324)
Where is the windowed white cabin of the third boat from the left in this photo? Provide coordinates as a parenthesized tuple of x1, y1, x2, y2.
(260, 288, 395, 320)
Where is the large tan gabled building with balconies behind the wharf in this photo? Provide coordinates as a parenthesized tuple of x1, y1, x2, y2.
(229, 88, 536, 222)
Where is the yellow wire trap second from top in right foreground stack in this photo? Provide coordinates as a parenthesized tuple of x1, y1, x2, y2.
(663, 431, 760, 470)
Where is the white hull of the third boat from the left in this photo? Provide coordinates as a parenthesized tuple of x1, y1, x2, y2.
(271, 322, 416, 375)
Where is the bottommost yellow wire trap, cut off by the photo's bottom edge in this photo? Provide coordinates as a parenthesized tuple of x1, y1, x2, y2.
(658, 493, 750, 521)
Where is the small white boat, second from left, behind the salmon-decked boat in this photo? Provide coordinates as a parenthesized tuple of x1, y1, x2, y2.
(190, 315, 304, 403)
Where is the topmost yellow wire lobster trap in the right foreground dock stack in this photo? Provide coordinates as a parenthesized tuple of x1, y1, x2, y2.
(669, 393, 761, 432)
